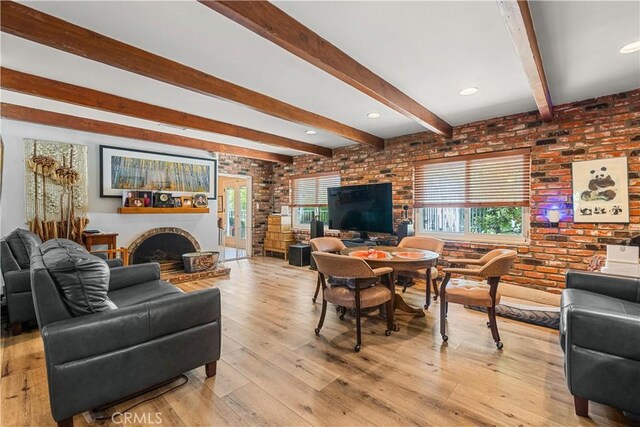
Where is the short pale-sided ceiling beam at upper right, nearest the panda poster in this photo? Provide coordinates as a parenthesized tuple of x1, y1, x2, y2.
(498, 0, 553, 121)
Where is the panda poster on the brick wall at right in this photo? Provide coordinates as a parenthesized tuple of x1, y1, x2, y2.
(571, 157, 629, 223)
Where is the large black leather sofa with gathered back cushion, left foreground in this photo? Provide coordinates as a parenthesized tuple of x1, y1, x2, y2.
(31, 242, 221, 426)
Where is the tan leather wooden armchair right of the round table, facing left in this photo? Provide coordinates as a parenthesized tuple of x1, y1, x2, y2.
(440, 249, 518, 349)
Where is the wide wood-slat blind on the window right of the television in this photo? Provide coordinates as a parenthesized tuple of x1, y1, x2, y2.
(414, 149, 531, 208)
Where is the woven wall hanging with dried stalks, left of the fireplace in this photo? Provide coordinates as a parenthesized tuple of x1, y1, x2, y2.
(24, 139, 89, 243)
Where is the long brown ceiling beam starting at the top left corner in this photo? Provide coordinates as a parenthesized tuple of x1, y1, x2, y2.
(0, 1, 384, 148)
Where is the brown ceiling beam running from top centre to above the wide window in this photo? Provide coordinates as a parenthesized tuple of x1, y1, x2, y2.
(198, 0, 452, 137)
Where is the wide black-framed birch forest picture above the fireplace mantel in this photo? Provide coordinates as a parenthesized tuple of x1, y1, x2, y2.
(100, 145, 218, 199)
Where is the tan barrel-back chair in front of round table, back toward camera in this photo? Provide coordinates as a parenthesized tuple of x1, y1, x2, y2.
(311, 251, 395, 352)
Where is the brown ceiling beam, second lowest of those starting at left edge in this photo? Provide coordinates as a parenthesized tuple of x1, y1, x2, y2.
(0, 68, 332, 157)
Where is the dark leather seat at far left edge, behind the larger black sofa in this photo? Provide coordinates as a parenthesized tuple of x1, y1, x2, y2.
(0, 228, 122, 335)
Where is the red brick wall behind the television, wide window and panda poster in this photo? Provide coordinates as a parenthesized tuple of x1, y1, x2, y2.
(273, 89, 640, 288)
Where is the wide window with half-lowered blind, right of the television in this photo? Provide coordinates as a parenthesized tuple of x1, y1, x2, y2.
(415, 150, 531, 242)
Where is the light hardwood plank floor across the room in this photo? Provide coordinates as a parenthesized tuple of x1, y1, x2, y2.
(0, 258, 630, 426)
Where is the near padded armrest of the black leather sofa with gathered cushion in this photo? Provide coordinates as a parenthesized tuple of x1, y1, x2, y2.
(41, 288, 220, 366)
